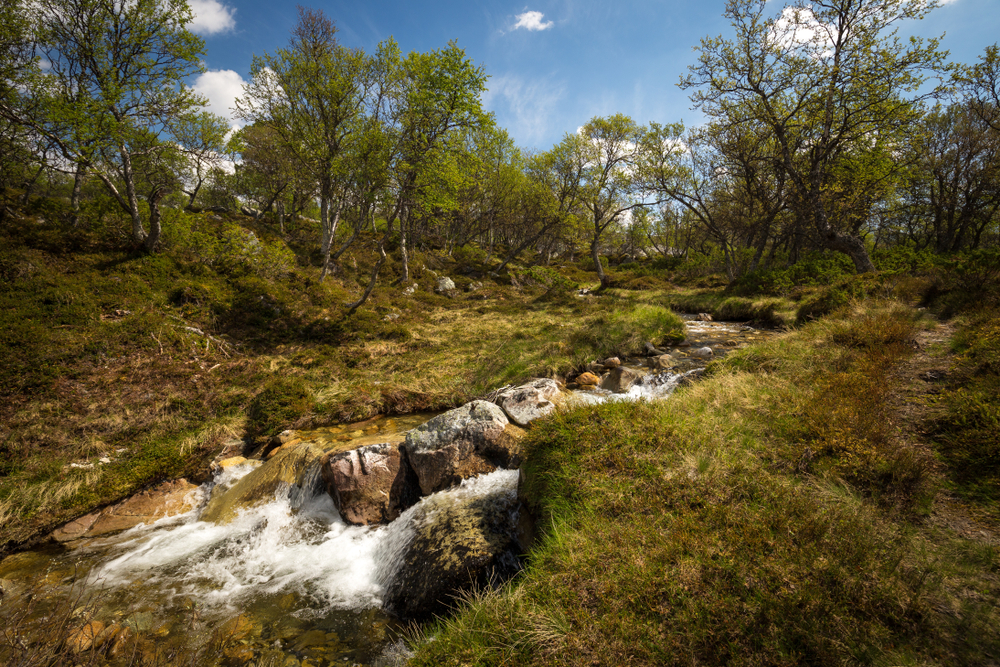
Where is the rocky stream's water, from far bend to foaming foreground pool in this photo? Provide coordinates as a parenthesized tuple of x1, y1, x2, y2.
(0, 321, 762, 666)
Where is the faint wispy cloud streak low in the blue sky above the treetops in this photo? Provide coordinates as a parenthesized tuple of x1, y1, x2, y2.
(483, 74, 565, 145)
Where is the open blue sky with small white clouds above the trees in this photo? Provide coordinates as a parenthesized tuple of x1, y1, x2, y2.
(189, 0, 1000, 150)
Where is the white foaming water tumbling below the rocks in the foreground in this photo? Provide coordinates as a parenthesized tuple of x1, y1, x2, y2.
(91, 468, 518, 610)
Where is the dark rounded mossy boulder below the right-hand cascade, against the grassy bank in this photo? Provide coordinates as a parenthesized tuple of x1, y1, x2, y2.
(383, 478, 524, 620)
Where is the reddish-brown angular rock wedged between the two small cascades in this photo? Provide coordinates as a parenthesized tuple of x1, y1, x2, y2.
(323, 442, 420, 525)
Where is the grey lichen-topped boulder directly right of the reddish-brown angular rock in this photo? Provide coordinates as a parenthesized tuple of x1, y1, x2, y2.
(404, 401, 518, 495)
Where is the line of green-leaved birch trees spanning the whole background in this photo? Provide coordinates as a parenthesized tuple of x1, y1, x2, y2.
(0, 0, 1000, 298)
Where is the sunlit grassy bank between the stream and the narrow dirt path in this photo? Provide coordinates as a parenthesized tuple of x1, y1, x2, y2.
(413, 302, 1000, 665)
